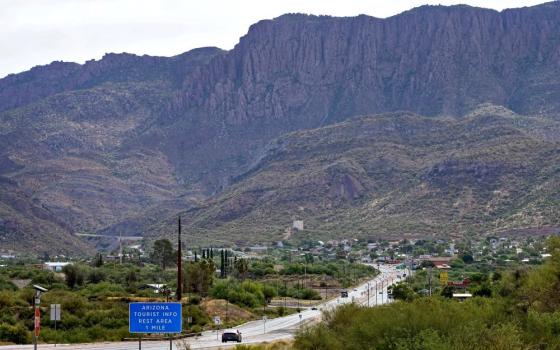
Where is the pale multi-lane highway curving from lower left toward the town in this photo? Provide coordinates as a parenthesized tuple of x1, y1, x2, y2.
(0, 265, 401, 350)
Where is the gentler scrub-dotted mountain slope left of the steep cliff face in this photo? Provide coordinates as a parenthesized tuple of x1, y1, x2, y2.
(0, 49, 220, 253)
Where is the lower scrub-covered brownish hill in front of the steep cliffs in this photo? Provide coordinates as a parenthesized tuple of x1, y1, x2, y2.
(158, 105, 560, 242)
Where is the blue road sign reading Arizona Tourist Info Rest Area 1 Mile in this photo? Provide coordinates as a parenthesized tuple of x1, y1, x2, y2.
(128, 303, 183, 333)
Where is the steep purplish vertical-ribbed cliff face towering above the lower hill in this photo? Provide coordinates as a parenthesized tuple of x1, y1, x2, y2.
(171, 2, 560, 189)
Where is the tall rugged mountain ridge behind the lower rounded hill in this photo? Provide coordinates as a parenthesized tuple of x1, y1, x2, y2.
(0, 2, 560, 254)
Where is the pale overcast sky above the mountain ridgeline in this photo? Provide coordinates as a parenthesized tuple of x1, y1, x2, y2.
(0, 0, 546, 78)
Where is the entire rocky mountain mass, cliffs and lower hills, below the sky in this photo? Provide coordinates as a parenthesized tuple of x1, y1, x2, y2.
(0, 2, 560, 252)
